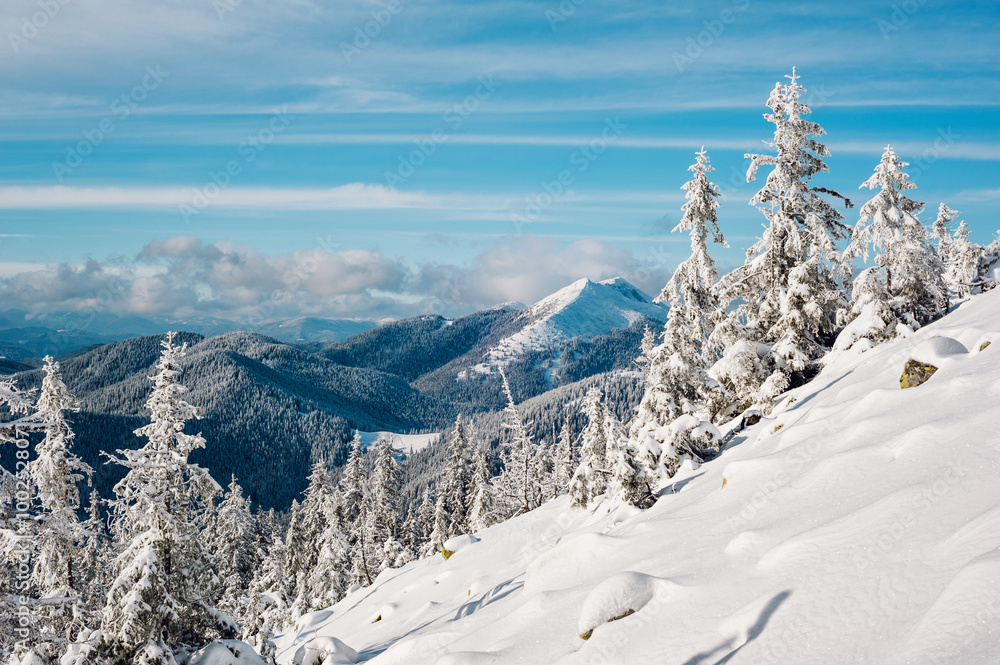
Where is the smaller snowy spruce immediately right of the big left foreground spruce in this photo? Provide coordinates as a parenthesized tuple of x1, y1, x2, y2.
(202, 475, 262, 624)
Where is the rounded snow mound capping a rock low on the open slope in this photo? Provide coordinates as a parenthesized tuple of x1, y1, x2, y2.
(576, 571, 676, 639)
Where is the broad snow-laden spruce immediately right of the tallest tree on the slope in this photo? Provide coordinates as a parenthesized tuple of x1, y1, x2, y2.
(837, 146, 948, 348)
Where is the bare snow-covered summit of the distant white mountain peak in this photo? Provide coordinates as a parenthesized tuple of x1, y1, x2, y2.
(475, 277, 667, 372)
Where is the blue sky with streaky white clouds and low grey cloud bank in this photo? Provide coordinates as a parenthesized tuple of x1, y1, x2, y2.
(0, 0, 1000, 323)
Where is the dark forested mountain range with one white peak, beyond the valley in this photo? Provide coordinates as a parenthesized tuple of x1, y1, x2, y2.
(0, 279, 666, 509)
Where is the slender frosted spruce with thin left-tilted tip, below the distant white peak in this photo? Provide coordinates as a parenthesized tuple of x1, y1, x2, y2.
(497, 368, 542, 519)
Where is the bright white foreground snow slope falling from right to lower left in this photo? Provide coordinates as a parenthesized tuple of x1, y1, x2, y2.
(279, 289, 1000, 665)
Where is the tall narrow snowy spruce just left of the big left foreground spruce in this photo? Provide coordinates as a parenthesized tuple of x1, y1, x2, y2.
(28, 356, 99, 636)
